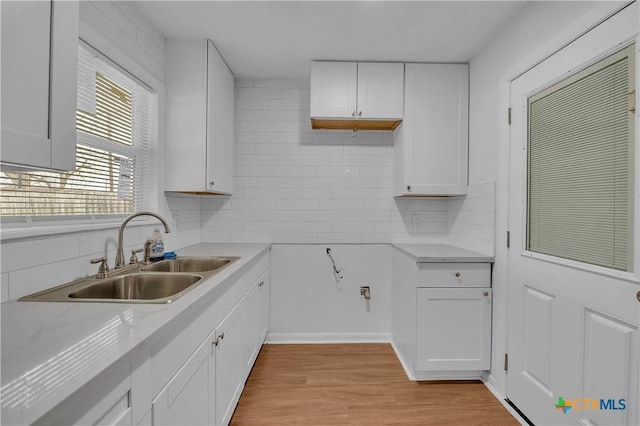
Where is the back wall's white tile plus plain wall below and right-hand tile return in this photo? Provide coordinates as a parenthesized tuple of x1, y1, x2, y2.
(201, 80, 495, 341)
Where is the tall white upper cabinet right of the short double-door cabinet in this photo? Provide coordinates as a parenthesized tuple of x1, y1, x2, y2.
(394, 64, 469, 197)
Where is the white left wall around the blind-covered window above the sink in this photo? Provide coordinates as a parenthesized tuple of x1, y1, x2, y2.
(0, 1, 201, 302)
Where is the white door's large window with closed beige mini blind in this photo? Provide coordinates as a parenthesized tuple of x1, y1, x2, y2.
(527, 46, 635, 272)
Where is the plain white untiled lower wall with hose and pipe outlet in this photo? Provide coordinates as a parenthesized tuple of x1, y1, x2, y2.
(268, 244, 391, 342)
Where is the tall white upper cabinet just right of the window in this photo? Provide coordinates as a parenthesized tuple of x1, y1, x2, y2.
(165, 40, 234, 195)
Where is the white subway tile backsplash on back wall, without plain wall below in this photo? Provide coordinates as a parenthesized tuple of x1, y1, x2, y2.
(202, 80, 484, 245)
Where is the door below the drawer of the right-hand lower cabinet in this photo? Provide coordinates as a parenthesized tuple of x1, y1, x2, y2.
(415, 288, 491, 371)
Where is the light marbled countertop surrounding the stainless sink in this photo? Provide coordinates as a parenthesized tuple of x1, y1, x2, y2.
(0, 243, 270, 424)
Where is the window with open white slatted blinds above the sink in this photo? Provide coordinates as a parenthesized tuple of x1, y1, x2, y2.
(0, 43, 157, 217)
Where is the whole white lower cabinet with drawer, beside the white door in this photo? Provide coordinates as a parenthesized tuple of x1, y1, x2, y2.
(391, 246, 492, 380)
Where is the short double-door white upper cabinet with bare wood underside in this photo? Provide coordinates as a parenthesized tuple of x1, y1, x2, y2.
(311, 61, 404, 130)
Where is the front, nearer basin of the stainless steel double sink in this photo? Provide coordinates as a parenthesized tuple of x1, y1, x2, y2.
(69, 273, 202, 300)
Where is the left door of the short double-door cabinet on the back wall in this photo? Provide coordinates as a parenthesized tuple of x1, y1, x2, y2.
(311, 62, 358, 118)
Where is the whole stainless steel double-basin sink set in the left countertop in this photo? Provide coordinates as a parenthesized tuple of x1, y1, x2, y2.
(20, 256, 239, 303)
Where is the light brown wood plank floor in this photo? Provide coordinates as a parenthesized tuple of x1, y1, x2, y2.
(231, 344, 519, 426)
